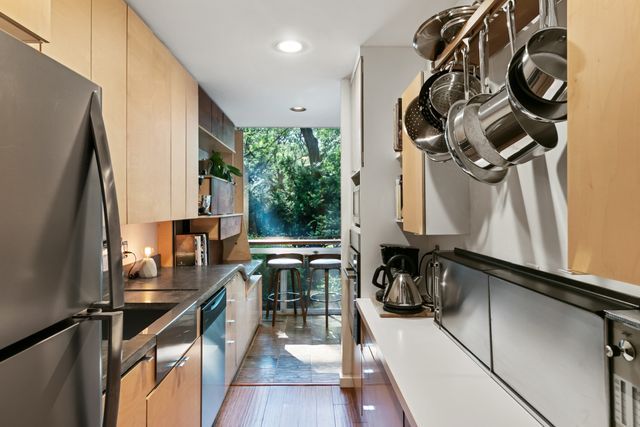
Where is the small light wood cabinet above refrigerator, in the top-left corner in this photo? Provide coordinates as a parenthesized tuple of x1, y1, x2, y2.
(0, 0, 51, 43)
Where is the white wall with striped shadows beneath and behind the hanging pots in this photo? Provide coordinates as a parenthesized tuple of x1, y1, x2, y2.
(464, 3, 568, 272)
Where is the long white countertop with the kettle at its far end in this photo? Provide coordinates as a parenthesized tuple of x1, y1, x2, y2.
(357, 298, 540, 427)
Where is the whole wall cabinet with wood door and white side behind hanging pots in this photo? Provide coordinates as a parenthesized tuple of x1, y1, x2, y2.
(402, 73, 469, 235)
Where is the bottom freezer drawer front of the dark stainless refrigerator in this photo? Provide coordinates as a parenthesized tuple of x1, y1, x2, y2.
(0, 321, 102, 427)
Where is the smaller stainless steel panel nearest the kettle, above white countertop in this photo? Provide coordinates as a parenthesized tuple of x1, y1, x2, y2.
(440, 258, 491, 367)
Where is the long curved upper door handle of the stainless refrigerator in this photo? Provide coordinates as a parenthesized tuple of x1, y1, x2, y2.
(89, 91, 124, 310)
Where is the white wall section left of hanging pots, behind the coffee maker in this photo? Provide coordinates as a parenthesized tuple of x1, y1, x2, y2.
(360, 47, 440, 298)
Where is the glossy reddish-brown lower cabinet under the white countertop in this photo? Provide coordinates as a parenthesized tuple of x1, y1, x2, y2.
(360, 324, 404, 427)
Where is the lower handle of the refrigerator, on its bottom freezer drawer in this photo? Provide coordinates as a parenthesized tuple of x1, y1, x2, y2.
(74, 309, 123, 427)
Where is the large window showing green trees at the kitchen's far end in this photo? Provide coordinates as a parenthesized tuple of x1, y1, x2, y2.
(244, 128, 340, 239)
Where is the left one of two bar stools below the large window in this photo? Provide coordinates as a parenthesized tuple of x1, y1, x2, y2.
(267, 253, 307, 326)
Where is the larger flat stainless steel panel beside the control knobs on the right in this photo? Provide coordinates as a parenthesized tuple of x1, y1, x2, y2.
(489, 277, 609, 427)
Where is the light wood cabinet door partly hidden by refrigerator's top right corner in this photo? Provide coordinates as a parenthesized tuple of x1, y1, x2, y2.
(42, 0, 91, 79)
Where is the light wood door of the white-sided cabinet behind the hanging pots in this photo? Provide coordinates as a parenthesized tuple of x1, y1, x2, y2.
(402, 73, 425, 234)
